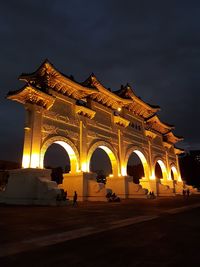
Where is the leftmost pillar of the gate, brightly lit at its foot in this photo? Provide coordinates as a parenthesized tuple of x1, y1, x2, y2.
(22, 104, 43, 168)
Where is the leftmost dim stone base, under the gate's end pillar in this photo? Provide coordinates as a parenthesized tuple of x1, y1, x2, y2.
(0, 169, 60, 205)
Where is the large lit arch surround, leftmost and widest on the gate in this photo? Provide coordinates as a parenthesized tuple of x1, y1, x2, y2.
(40, 136, 79, 173)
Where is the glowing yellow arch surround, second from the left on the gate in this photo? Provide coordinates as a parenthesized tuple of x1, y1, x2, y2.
(87, 140, 119, 177)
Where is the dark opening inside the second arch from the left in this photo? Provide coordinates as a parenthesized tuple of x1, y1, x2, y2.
(90, 148, 112, 183)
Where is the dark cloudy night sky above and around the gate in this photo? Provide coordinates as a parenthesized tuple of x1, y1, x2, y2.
(0, 0, 200, 161)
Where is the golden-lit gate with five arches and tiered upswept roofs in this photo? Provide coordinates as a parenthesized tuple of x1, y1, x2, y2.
(8, 61, 186, 197)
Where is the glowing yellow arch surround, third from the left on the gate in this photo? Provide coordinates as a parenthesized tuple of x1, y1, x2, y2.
(122, 146, 150, 179)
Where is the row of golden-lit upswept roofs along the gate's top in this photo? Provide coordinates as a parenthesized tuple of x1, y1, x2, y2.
(8, 60, 178, 134)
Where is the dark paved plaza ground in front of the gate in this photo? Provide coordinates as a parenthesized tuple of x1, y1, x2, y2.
(0, 195, 200, 267)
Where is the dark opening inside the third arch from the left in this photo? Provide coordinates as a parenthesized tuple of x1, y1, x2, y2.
(127, 152, 145, 184)
